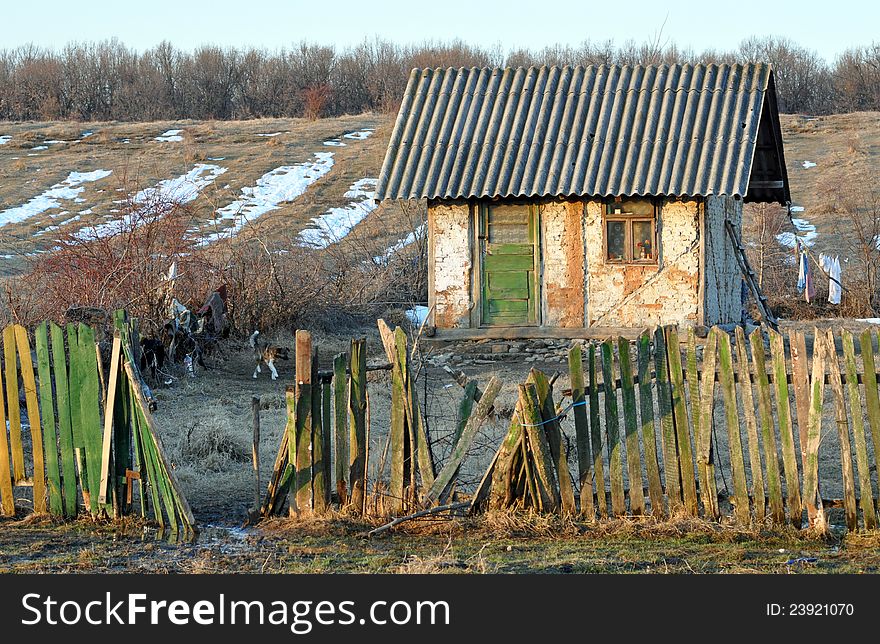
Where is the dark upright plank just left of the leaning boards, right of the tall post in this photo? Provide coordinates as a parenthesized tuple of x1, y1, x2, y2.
(348, 339, 369, 514)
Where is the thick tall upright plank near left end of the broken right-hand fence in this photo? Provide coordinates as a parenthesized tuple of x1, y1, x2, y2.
(293, 329, 314, 516)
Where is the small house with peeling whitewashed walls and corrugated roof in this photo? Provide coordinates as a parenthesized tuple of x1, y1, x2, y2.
(377, 64, 790, 337)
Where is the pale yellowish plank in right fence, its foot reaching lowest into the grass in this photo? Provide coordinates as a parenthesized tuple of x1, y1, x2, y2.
(802, 327, 828, 533)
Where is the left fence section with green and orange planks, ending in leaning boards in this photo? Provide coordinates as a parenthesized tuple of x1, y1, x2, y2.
(0, 311, 195, 534)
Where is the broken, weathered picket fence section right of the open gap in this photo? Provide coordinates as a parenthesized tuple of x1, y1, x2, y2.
(261, 321, 880, 530)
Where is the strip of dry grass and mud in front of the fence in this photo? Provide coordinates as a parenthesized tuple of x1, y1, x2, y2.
(0, 515, 880, 574)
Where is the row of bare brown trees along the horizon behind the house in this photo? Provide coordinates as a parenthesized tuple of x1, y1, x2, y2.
(0, 36, 880, 121)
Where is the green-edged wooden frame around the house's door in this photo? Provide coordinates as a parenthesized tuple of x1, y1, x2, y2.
(469, 199, 544, 329)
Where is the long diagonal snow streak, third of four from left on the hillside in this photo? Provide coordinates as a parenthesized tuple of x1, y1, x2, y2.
(199, 152, 333, 245)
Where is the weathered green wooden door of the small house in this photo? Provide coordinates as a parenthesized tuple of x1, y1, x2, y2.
(480, 204, 538, 326)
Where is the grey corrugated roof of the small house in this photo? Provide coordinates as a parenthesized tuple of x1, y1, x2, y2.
(376, 63, 788, 199)
